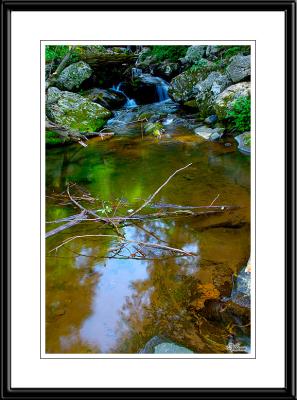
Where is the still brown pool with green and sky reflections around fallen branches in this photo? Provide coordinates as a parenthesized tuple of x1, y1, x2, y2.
(46, 128, 250, 353)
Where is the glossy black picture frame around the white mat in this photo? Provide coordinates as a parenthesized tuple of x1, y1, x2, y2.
(1, 0, 297, 399)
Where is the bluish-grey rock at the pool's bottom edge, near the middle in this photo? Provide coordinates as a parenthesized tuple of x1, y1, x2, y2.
(139, 336, 194, 354)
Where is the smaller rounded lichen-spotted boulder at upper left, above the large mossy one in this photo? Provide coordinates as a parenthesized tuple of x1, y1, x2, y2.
(56, 61, 92, 90)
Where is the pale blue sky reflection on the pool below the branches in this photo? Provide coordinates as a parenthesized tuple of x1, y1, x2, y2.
(76, 225, 199, 353)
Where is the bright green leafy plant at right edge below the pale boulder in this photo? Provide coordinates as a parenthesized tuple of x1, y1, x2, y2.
(227, 96, 251, 132)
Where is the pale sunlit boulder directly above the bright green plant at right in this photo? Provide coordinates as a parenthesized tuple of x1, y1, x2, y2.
(214, 82, 251, 120)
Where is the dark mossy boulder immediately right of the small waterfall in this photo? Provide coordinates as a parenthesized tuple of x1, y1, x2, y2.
(168, 69, 205, 103)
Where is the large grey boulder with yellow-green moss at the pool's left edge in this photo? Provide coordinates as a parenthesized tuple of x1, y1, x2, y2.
(46, 87, 111, 133)
